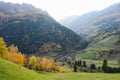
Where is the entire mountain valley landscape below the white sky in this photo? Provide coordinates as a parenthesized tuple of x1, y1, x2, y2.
(0, 1, 120, 80)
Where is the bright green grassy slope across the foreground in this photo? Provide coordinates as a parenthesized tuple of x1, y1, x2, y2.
(0, 59, 120, 80)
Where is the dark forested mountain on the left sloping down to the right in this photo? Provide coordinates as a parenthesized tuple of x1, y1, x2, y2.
(0, 2, 87, 54)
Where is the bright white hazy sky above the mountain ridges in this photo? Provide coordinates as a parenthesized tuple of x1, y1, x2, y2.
(0, 0, 120, 21)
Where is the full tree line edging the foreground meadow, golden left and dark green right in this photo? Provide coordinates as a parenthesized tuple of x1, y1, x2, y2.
(0, 38, 120, 73)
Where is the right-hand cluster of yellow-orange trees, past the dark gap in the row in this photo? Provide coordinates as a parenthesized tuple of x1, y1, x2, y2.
(29, 56, 64, 72)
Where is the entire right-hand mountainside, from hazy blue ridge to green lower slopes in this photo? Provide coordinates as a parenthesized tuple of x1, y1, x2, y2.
(60, 3, 120, 59)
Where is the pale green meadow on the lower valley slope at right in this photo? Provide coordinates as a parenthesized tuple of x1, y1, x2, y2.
(76, 36, 120, 60)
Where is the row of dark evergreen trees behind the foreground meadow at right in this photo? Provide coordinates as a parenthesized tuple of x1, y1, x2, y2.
(65, 56, 120, 73)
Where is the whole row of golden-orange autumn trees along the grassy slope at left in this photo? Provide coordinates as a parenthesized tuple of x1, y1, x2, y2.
(0, 38, 64, 72)
